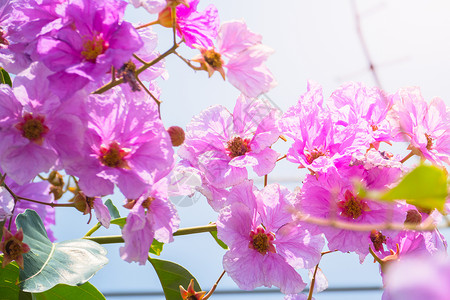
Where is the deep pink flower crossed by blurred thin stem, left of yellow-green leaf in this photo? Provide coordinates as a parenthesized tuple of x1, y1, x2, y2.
(297, 166, 405, 262)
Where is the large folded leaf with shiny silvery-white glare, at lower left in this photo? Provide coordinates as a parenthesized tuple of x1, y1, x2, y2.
(16, 209, 108, 293)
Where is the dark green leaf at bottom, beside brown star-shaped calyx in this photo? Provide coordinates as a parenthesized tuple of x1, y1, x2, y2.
(149, 258, 201, 300)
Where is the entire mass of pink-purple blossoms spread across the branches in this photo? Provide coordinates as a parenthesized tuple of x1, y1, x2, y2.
(0, 0, 450, 299)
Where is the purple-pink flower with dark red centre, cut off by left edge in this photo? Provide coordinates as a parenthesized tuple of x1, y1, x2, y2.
(0, 63, 85, 184)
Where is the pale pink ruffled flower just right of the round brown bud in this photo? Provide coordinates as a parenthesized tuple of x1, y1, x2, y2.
(178, 95, 279, 188)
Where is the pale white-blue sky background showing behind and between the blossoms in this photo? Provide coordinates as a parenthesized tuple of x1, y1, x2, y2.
(54, 0, 450, 300)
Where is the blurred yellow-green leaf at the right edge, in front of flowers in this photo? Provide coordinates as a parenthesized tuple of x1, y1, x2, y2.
(381, 165, 448, 211)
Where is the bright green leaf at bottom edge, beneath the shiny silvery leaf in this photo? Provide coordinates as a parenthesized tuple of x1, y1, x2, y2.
(33, 282, 105, 300)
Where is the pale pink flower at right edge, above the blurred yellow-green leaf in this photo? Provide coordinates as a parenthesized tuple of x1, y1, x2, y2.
(393, 88, 450, 164)
